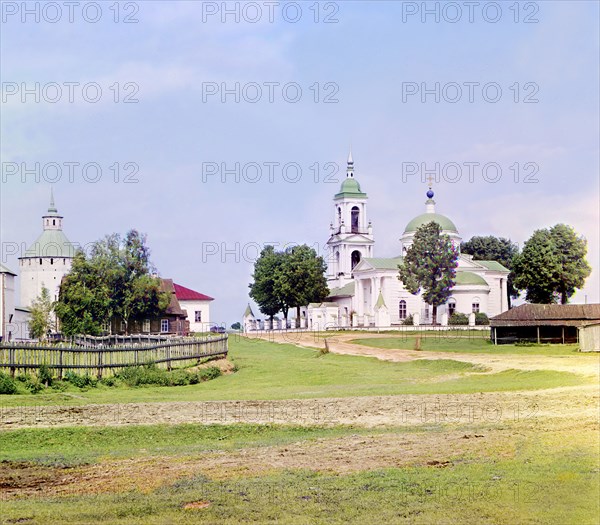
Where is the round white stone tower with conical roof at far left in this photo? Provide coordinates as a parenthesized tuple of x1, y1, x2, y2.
(19, 190, 75, 308)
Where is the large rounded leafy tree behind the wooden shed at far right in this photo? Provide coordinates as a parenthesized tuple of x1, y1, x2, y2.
(514, 224, 591, 304)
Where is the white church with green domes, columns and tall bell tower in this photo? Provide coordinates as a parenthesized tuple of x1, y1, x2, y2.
(244, 154, 509, 330)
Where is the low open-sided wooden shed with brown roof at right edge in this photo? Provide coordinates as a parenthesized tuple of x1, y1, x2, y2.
(490, 304, 600, 344)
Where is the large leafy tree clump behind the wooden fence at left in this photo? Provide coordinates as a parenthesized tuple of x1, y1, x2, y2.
(56, 230, 170, 335)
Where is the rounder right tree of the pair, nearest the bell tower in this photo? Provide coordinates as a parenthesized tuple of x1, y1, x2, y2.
(279, 244, 329, 328)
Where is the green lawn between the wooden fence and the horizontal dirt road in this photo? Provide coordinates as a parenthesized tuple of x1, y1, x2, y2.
(0, 338, 590, 408)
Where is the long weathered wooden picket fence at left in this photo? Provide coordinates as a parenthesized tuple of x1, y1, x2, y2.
(0, 335, 228, 378)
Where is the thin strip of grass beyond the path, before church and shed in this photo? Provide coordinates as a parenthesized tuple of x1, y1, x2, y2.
(350, 332, 589, 358)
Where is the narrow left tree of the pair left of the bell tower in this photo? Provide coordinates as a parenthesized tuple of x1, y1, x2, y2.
(249, 246, 284, 329)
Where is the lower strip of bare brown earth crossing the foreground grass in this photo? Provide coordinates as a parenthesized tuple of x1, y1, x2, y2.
(0, 419, 598, 499)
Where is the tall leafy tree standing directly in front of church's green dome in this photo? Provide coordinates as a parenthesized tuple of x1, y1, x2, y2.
(398, 221, 458, 324)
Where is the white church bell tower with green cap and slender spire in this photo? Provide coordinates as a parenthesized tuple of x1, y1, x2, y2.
(327, 152, 375, 288)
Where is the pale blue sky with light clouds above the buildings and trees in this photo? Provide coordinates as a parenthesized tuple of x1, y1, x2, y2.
(0, 0, 600, 324)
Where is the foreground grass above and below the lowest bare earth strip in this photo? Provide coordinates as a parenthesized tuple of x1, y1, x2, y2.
(0, 423, 600, 525)
